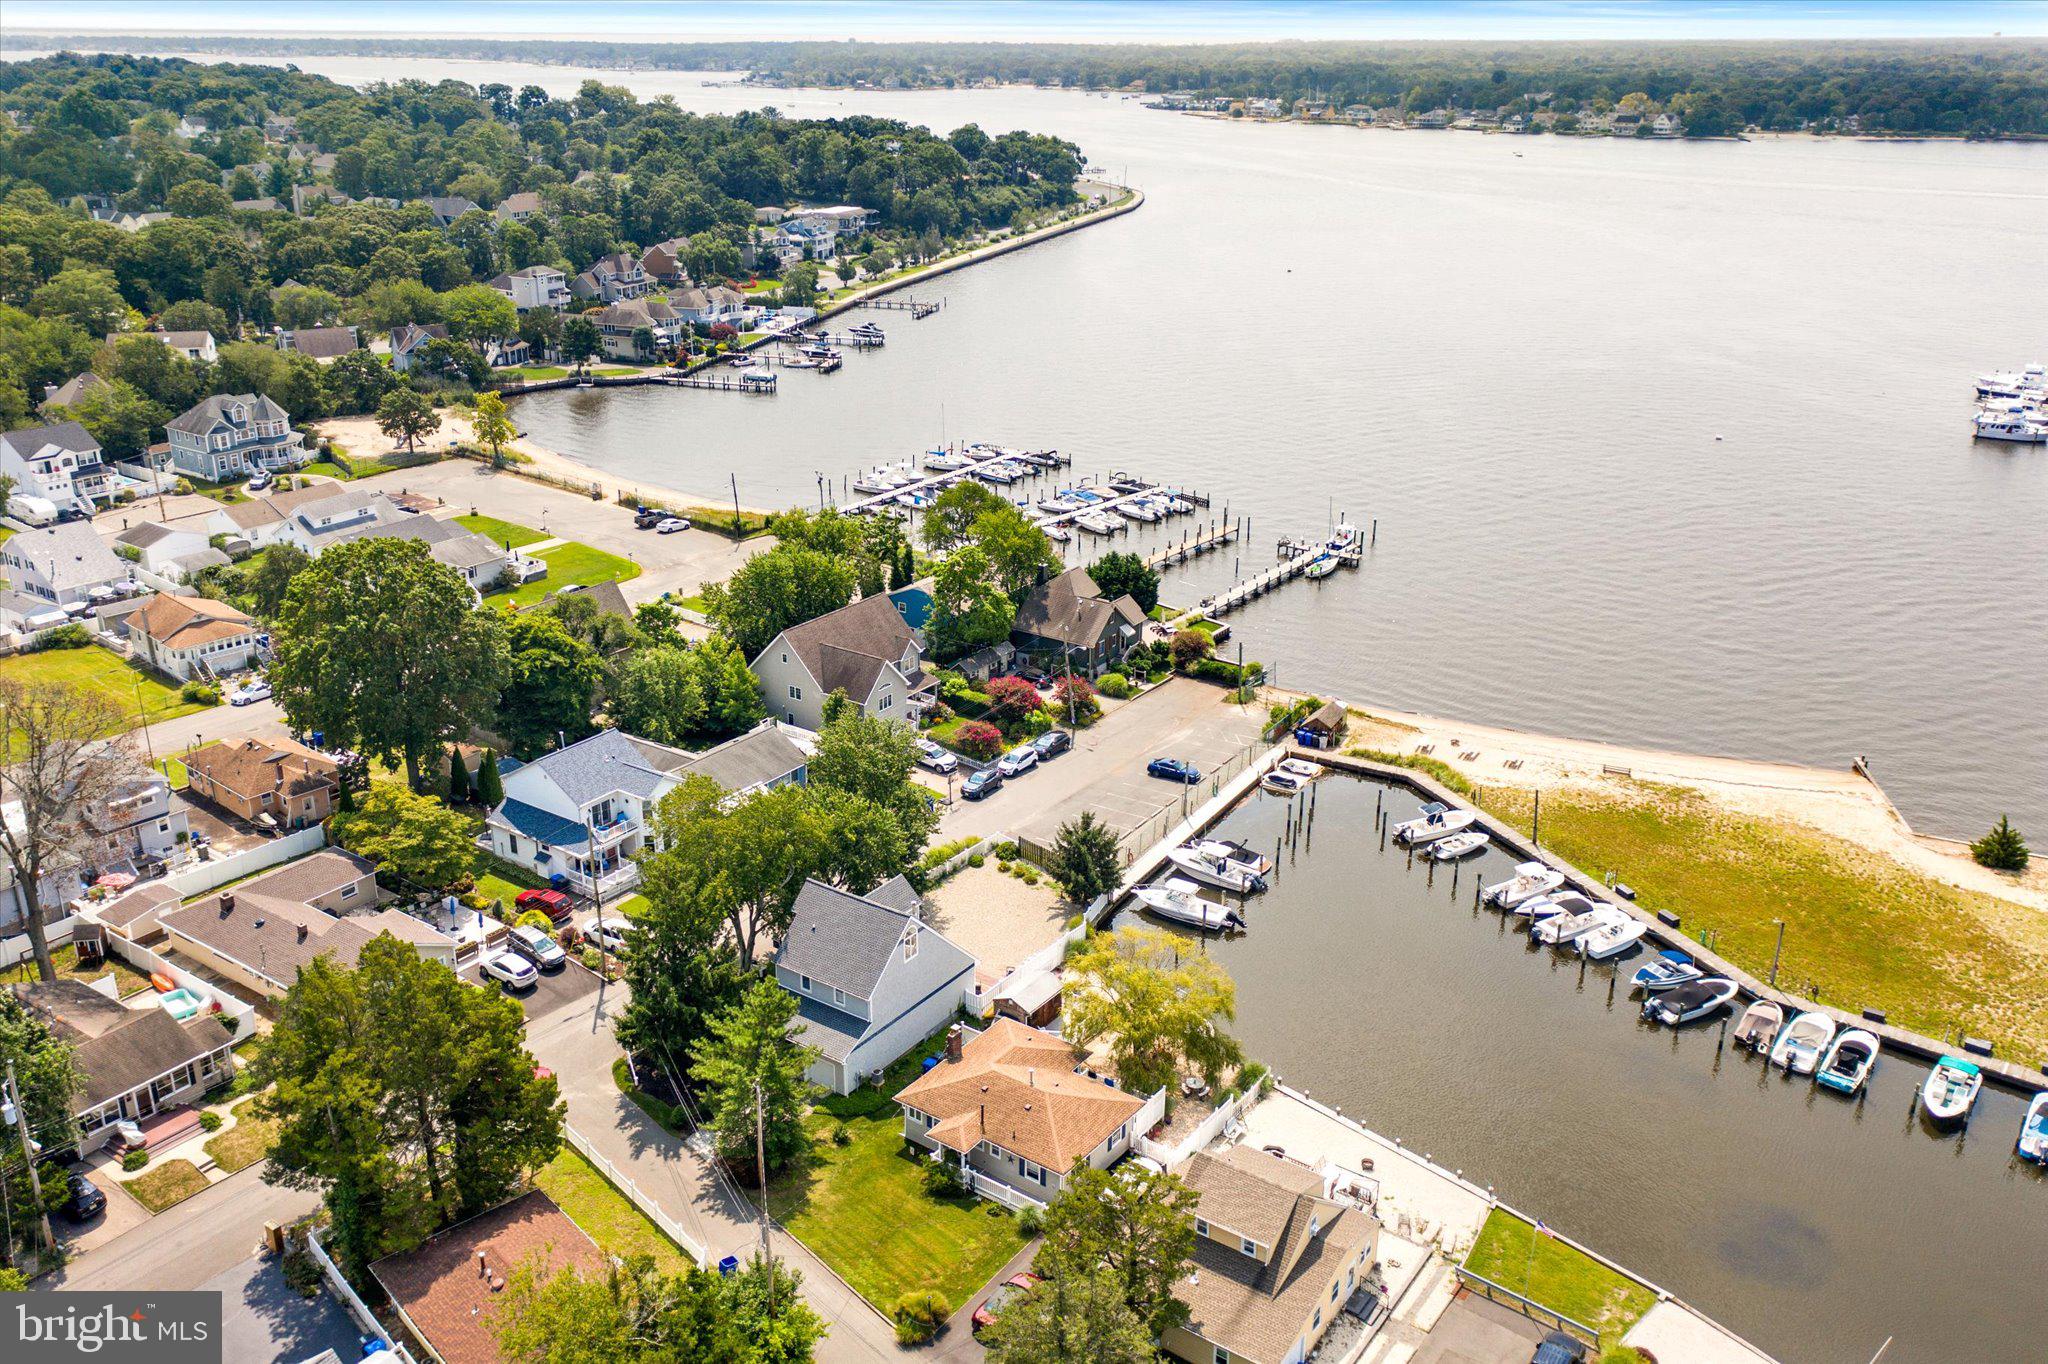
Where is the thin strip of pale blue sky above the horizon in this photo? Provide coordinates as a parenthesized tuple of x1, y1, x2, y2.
(4, 0, 2048, 43)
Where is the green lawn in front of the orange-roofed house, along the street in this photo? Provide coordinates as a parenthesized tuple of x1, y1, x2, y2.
(768, 1104, 1024, 1313)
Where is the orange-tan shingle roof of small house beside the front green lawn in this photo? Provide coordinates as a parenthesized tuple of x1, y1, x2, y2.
(895, 1018, 1145, 1171)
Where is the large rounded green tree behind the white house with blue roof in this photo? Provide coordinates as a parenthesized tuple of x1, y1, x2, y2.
(268, 537, 510, 786)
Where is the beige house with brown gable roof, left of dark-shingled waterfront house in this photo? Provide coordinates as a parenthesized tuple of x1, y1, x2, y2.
(750, 596, 932, 729)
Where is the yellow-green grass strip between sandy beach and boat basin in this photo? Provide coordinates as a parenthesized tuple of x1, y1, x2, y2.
(1485, 782, 2048, 1065)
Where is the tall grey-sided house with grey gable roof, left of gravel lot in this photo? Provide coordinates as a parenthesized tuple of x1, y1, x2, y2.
(774, 877, 975, 1094)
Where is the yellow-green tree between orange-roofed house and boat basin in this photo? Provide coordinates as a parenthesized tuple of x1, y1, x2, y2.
(1065, 928, 1243, 1094)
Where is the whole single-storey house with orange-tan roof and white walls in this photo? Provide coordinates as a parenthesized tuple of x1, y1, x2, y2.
(895, 1018, 1165, 1206)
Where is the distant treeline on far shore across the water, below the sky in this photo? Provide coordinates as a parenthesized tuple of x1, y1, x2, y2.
(6, 33, 2048, 137)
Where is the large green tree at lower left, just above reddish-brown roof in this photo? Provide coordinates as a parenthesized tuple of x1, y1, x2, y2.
(254, 934, 565, 1270)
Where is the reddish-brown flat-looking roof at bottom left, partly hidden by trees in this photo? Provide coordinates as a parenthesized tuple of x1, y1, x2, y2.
(371, 1190, 604, 1364)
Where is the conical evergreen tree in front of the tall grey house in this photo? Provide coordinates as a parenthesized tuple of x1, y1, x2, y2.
(690, 977, 821, 1171)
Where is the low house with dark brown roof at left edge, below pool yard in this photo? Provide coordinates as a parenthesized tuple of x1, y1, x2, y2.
(10, 981, 236, 1155)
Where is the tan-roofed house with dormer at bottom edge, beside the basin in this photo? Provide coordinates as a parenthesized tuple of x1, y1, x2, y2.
(1159, 1145, 1380, 1364)
